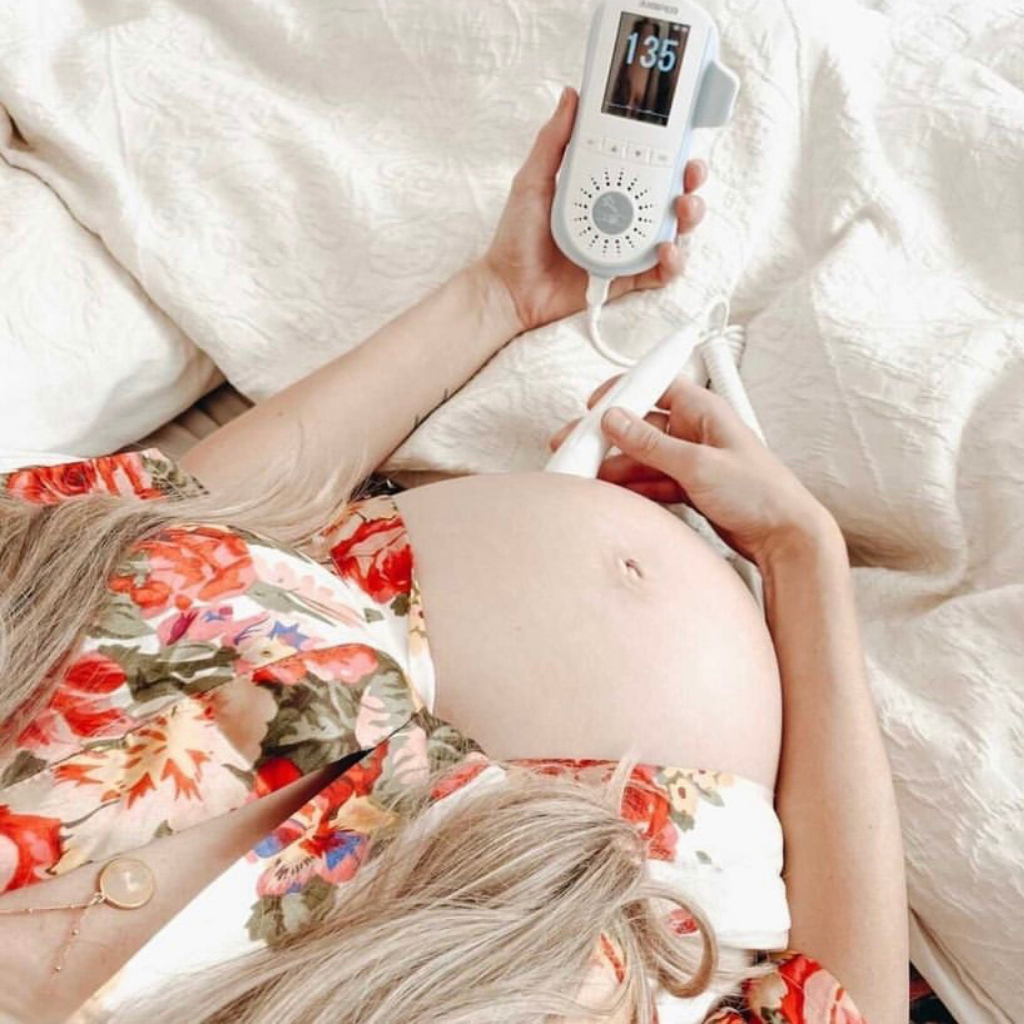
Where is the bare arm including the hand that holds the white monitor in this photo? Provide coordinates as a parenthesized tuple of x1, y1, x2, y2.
(181, 89, 707, 489)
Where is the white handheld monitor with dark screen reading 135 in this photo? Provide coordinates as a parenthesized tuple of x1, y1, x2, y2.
(551, 0, 738, 278)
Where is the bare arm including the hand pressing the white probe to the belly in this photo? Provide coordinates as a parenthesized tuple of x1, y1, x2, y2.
(555, 377, 908, 1024)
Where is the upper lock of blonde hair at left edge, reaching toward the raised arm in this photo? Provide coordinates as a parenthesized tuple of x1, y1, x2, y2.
(0, 425, 357, 760)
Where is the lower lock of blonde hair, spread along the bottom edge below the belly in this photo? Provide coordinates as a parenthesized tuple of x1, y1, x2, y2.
(108, 759, 770, 1024)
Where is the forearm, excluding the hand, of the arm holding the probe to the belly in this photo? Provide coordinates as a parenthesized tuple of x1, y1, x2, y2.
(761, 518, 907, 1024)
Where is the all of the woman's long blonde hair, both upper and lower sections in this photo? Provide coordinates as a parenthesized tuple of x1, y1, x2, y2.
(0, 437, 771, 1024)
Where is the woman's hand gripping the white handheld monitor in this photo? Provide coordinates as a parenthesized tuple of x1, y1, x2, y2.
(481, 87, 708, 331)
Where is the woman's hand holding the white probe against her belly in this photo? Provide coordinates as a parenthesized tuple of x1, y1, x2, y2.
(551, 376, 839, 568)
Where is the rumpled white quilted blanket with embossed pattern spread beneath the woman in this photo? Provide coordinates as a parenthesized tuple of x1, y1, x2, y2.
(0, 0, 1024, 1022)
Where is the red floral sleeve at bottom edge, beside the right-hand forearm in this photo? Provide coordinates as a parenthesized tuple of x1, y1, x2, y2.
(706, 949, 866, 1024)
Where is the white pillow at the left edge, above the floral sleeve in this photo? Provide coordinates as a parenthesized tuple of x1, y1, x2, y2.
(0, 108, 223, 471)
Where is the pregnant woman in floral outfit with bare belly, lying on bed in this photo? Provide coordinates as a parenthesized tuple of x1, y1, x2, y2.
(0, 90, 907, 1024)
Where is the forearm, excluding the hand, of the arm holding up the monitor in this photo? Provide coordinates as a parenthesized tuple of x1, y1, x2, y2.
(181, 262, 519, 490)
